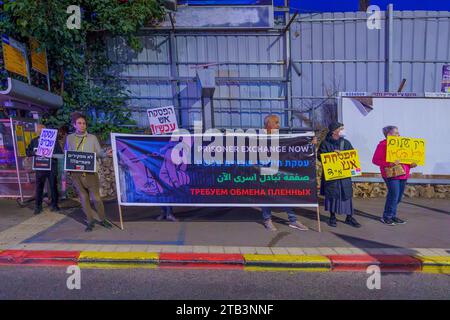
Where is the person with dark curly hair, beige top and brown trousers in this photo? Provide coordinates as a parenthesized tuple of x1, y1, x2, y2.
(64, 112, 112, 232)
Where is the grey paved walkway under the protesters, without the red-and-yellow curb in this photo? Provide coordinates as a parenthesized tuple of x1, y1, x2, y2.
(0, 199, 450, 256)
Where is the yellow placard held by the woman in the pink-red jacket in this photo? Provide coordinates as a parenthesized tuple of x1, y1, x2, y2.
(386, 136, 426, 166)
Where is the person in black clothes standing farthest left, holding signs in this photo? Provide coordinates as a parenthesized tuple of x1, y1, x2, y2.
(26, 124, 63, 214)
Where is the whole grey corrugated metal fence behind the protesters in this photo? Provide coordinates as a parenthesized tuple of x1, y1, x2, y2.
(109, 6, 450, 131)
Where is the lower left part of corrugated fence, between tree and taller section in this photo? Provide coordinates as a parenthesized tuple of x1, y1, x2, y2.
(110, 32, 286, 128)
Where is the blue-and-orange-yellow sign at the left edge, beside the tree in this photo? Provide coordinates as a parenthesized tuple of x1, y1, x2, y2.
(2, 36, 28, 78)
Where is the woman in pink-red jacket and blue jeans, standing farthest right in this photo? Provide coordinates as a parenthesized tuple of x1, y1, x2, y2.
(372, 126, 417, 226)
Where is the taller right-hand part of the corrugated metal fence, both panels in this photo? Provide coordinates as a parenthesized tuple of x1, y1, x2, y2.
(291, 11, 450, 126)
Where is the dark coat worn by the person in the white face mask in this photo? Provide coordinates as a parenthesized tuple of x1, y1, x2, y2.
(317, 134, 353, 200)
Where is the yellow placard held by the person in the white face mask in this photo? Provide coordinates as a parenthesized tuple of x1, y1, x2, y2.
(320, 150, 362, 181)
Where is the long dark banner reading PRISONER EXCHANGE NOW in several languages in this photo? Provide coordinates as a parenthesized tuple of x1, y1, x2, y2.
(111, 132, 318, 231)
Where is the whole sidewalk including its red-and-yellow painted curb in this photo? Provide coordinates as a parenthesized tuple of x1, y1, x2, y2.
(0, 199, 450, 272)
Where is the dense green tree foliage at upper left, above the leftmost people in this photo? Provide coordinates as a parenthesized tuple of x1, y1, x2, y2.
(0, 0, 164, 140)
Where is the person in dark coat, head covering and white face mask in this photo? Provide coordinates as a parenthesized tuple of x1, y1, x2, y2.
(317, 122, 361, 228)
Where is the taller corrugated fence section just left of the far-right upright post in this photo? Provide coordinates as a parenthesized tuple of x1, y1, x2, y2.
(291, 12, 385, 126)
